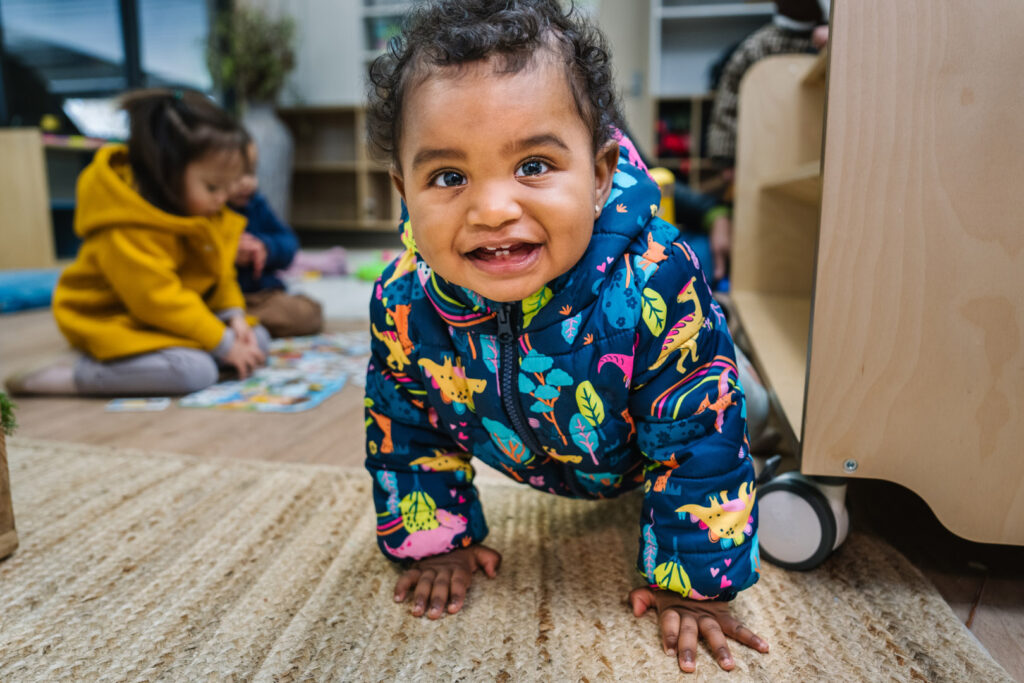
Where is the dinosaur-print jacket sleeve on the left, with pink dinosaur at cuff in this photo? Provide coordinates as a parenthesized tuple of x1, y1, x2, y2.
(365, 281, 487, 560)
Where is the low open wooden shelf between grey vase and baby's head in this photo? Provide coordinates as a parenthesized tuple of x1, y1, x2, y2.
(280, 106, 401, 232)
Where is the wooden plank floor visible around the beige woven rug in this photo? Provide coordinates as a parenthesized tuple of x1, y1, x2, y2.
(0, 310, 1024, 683)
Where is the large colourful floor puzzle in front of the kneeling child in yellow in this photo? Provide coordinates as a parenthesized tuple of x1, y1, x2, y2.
(178, 332, 370, 413)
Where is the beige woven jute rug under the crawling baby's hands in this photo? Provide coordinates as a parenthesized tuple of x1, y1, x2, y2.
(0, 438, 1011, 682)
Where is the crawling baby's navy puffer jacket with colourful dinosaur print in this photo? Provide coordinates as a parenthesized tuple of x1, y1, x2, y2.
(366, 148, 760, 600)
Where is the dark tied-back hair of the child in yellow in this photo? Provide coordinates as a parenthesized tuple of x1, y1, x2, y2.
(121, 88, 249, 215)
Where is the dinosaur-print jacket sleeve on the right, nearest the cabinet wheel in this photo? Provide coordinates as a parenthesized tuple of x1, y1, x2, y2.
(633, 237, 760, 600)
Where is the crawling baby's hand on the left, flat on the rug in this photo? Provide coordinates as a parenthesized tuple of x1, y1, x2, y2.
(394, 545, 502, 618)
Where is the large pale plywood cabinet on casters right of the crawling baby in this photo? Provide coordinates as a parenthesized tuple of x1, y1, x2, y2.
(732, 0, 1024, 545)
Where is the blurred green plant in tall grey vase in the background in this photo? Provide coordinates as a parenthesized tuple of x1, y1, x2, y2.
(206, 6, 295, 218)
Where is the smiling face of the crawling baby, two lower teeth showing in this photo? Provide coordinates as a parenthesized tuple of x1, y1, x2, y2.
(393, 58, 618, 301)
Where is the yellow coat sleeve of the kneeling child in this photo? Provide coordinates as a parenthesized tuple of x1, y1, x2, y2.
(97, 227, 228, 351)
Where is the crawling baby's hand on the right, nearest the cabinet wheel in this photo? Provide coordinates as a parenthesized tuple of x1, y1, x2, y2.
(629, 588, 768, 674)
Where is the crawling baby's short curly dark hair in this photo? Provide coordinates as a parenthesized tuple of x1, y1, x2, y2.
(367, 0, 622, 166)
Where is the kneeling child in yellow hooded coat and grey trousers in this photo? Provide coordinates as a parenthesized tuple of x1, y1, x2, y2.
(7, 90, 269, 395)
